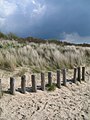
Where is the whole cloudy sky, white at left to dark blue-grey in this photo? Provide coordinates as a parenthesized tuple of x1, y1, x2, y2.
(0, 0, 90, 43)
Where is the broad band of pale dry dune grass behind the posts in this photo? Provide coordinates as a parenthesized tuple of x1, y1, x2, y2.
(0, 40, 90, 72)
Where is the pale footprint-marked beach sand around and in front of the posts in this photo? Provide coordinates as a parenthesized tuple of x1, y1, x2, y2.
(0, 69, 90, 120)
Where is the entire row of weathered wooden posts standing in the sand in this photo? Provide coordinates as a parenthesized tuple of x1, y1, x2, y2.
(0, 67, 85, 95)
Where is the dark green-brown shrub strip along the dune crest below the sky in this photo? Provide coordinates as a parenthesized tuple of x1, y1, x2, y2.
(0, 32, 90, 47)
